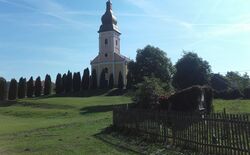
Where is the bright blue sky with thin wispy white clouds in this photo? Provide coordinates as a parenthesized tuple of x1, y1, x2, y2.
(0, 0, 250, 80)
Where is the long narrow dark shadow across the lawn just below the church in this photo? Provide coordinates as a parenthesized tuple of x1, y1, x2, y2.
(80, 104, 131, 115)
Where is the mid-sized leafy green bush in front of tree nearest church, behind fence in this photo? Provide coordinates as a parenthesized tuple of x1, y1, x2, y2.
(134, 77, 164, 108)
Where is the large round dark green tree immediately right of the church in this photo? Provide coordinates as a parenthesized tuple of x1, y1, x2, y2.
(128, 45, 174, 83)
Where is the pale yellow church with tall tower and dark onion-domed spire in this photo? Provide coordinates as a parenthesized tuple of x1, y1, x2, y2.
(91, 0, 130, 86)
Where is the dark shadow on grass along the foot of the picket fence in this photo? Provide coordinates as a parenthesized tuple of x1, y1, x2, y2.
(94, 127, 143, 154)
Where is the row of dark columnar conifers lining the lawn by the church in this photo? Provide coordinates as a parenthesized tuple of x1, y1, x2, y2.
(0, 68, 129, 100)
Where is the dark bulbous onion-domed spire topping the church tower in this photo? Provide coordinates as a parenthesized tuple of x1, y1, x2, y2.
(98, 0, 120, 33)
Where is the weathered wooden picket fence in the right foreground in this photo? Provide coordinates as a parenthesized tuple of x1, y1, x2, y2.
(113, 106, 250, 155)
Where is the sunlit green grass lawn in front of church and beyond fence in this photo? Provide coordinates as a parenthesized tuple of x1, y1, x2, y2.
(0, 96, 250, 155)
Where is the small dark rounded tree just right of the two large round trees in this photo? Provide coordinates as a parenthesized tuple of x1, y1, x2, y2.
(211, 74, 230, 91)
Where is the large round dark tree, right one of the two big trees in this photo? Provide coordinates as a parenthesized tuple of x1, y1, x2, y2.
(173, 52, 211, 89)
